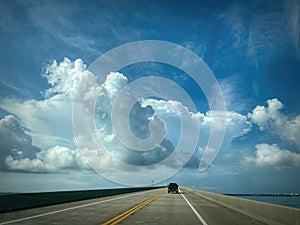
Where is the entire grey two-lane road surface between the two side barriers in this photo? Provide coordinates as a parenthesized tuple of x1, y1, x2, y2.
(0, 188, 263, 225)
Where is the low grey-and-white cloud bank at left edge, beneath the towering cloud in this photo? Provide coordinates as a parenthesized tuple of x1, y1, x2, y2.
(0, 115, 85, 173)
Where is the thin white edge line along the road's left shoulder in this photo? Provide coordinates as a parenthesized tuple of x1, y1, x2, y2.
(0, 190, 161, 225)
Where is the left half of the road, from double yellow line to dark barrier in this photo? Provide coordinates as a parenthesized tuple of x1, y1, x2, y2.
(0, 189, 162, 225)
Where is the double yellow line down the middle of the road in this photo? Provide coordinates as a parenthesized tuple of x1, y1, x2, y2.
(102, 191, 165, 225)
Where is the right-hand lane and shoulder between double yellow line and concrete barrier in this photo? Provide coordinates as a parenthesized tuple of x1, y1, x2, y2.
(115, 188, 264, 225)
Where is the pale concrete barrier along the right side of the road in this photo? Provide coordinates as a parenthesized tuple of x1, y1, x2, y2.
(187, 189, 300, 225)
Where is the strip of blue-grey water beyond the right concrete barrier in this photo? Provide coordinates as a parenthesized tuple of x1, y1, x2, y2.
(237, 196, 300, 208)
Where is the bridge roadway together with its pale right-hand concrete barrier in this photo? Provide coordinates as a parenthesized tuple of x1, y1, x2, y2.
(0, 187, 300, 225)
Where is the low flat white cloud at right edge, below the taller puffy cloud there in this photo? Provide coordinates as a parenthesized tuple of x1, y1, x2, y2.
(245, 143, 300, 169)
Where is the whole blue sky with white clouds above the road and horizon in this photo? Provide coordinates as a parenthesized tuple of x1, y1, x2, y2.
(0, 0, 300, 193)
